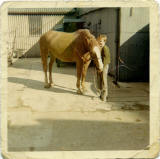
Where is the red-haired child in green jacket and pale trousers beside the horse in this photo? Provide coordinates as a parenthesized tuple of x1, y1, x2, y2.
(97, 34, 110, 101)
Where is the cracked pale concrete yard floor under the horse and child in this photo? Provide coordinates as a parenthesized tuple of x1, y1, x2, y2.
(8, 58, 149, 151)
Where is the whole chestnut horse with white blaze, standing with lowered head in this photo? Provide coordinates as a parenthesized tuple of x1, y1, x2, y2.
(39, 29, 103, 94)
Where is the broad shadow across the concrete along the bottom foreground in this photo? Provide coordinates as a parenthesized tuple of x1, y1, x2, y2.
(8, 119, 149, 151)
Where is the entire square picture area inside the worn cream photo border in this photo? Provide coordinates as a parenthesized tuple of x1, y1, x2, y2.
(7, 6, 150, 152)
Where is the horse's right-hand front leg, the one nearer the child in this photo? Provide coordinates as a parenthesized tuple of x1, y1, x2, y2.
(81, 60, 91, 92)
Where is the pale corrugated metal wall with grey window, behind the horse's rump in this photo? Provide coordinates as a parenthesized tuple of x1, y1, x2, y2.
(8, 9, 67, 57)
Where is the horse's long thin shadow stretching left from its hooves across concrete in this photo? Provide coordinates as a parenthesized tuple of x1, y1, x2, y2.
(8, 77, 94, 98)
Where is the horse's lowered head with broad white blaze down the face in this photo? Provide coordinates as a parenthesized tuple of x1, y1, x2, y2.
(82, 31, 103, 72)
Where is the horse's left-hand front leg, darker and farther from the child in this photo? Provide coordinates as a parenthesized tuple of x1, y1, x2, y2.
(76, 61, 83, 94)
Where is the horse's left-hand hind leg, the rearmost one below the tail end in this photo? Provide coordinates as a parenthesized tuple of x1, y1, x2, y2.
(40, 48, 50, 88)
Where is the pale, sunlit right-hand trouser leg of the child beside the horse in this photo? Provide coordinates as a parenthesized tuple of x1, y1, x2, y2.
(101, 64, 109, 101)
